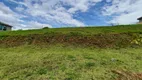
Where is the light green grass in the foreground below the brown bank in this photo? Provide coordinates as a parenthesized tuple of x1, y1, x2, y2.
(0, 45, 142, 80)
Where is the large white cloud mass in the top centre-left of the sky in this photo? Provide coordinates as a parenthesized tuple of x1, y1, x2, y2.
(4, 0, 102, 29)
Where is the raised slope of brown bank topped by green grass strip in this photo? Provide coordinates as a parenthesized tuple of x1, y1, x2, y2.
(0, 25, 142, 48)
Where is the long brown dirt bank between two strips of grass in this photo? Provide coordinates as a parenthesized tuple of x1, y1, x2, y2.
(0, 33, 140, 48)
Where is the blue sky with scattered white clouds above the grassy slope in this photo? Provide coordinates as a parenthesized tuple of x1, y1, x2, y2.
(0, 0, 142, 30)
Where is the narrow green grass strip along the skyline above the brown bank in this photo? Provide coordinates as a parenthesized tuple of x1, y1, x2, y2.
(0, 25, 142, 36)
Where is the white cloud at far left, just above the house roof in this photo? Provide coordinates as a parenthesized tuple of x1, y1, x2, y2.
(0, 2, 51, 30)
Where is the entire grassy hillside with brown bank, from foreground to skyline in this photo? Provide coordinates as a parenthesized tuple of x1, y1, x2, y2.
(0, 25, 142, 80)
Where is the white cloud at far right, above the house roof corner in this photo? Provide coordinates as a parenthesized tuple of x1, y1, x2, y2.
(103, 0, 142, 24)
